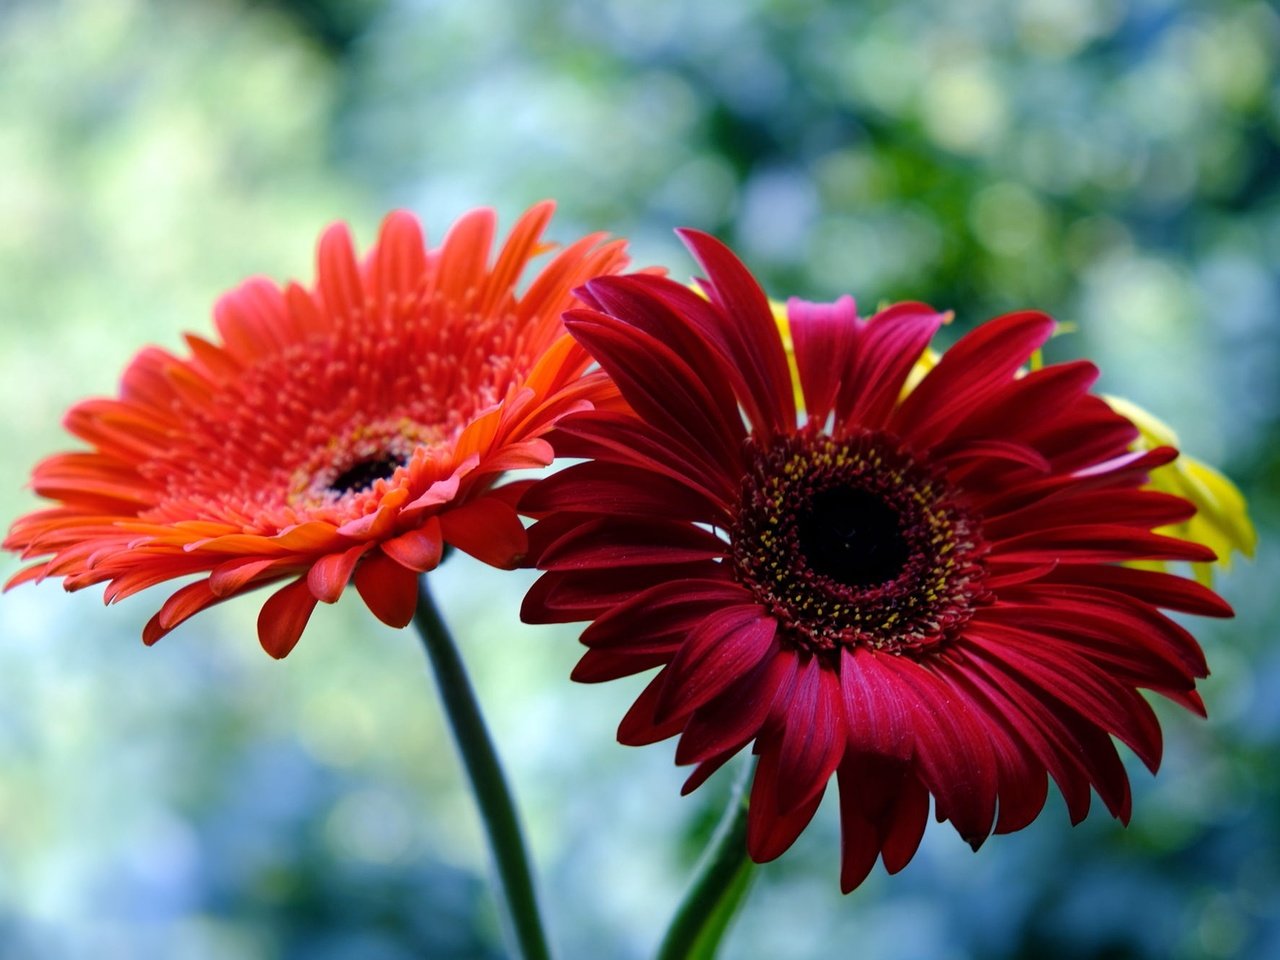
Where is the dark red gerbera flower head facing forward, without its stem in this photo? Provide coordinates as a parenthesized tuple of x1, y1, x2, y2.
(522, 232, 1230, 891)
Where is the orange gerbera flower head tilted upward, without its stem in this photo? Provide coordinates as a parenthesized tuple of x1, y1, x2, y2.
(4, 202, 625, 657)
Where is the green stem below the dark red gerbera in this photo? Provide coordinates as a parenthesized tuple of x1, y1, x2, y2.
(657, 763, 754, 960)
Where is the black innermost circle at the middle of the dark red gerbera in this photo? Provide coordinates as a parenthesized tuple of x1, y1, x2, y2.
(796, 486, 911, 586)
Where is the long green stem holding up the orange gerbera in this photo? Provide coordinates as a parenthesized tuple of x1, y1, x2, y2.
(413, 576, 552, 960)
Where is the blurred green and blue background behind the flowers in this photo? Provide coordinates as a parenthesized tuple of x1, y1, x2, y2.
(0, 0, 1280, 960)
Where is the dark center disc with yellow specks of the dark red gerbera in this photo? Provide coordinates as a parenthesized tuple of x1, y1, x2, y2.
(730, 430, 987, 653)
